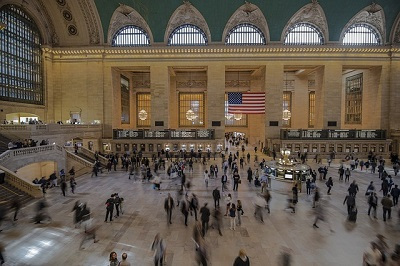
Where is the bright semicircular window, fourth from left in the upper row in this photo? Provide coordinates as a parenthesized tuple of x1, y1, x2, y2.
(283, 23, 324, 45)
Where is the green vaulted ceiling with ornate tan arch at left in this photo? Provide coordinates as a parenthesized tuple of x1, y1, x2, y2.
(0, 0, 400, 46)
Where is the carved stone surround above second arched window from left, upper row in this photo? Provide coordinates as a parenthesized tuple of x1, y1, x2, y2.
(164, 1, 211, 44)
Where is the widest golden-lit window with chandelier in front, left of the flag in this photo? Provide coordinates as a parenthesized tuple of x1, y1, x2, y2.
(179, 92, 205, 127)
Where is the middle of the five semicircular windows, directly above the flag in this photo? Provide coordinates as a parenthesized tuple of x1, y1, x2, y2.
(225, 23, 266, 45)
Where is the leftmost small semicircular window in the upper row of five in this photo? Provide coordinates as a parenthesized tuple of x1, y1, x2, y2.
(111, 25, 150, 47)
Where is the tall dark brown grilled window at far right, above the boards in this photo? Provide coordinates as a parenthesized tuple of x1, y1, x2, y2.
(345, 73, 363, 124)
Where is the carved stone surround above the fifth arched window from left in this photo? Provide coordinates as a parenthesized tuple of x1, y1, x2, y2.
(339, 3, 386, 44)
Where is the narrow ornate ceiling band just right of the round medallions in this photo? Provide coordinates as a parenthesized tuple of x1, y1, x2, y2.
(77, 0, 101, 44)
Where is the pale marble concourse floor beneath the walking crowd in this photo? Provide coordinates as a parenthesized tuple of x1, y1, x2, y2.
(0, 149, 400, 266)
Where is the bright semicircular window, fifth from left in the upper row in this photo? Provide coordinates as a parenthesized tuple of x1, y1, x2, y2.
(343, 24, 382, 45)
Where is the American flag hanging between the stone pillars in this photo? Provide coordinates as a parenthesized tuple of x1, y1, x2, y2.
(228, 92, 265, 114)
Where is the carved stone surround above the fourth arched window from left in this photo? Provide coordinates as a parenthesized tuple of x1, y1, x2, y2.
(281, 0, 329, 43)
